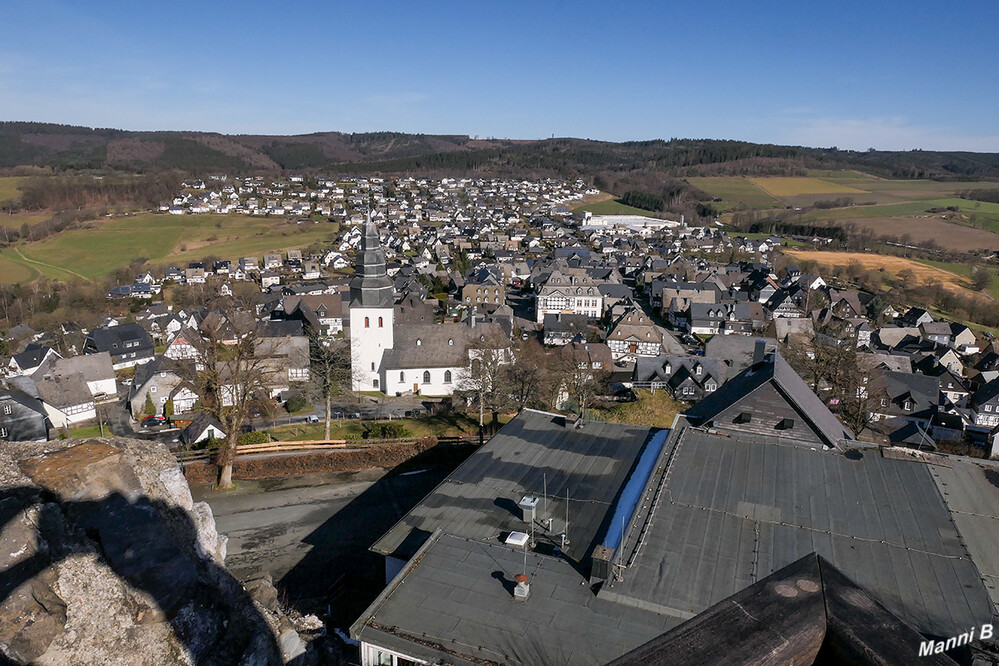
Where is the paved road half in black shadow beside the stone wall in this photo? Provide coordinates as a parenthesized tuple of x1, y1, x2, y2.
(192, 459, 457, 627)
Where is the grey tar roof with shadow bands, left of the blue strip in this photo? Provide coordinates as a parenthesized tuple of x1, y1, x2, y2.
(372, 410, 654, 561)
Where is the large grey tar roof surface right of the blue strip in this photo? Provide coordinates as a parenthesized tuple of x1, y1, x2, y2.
(600, 428, 995, 636)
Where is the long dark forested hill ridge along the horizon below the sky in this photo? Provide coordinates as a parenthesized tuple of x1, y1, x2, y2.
(0, 122, 999, 180)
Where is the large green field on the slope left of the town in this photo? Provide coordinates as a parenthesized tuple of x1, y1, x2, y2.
(0, 214, 337, 282)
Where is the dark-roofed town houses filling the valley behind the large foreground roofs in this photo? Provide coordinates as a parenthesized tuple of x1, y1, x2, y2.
(0, 171, 999, 457)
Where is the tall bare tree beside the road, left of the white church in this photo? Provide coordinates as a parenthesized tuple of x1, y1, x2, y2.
(191, 304, 275, 490)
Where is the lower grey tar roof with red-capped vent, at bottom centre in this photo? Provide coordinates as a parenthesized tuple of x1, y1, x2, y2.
(352, 534, 680, 665)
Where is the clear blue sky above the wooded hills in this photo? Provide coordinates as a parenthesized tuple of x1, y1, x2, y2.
(0, 0, 999, 151)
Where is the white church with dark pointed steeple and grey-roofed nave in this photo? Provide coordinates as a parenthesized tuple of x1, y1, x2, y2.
(350, 216, 502, 397)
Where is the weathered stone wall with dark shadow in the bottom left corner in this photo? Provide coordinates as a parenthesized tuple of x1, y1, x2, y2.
(0, 438, 322, 665)
